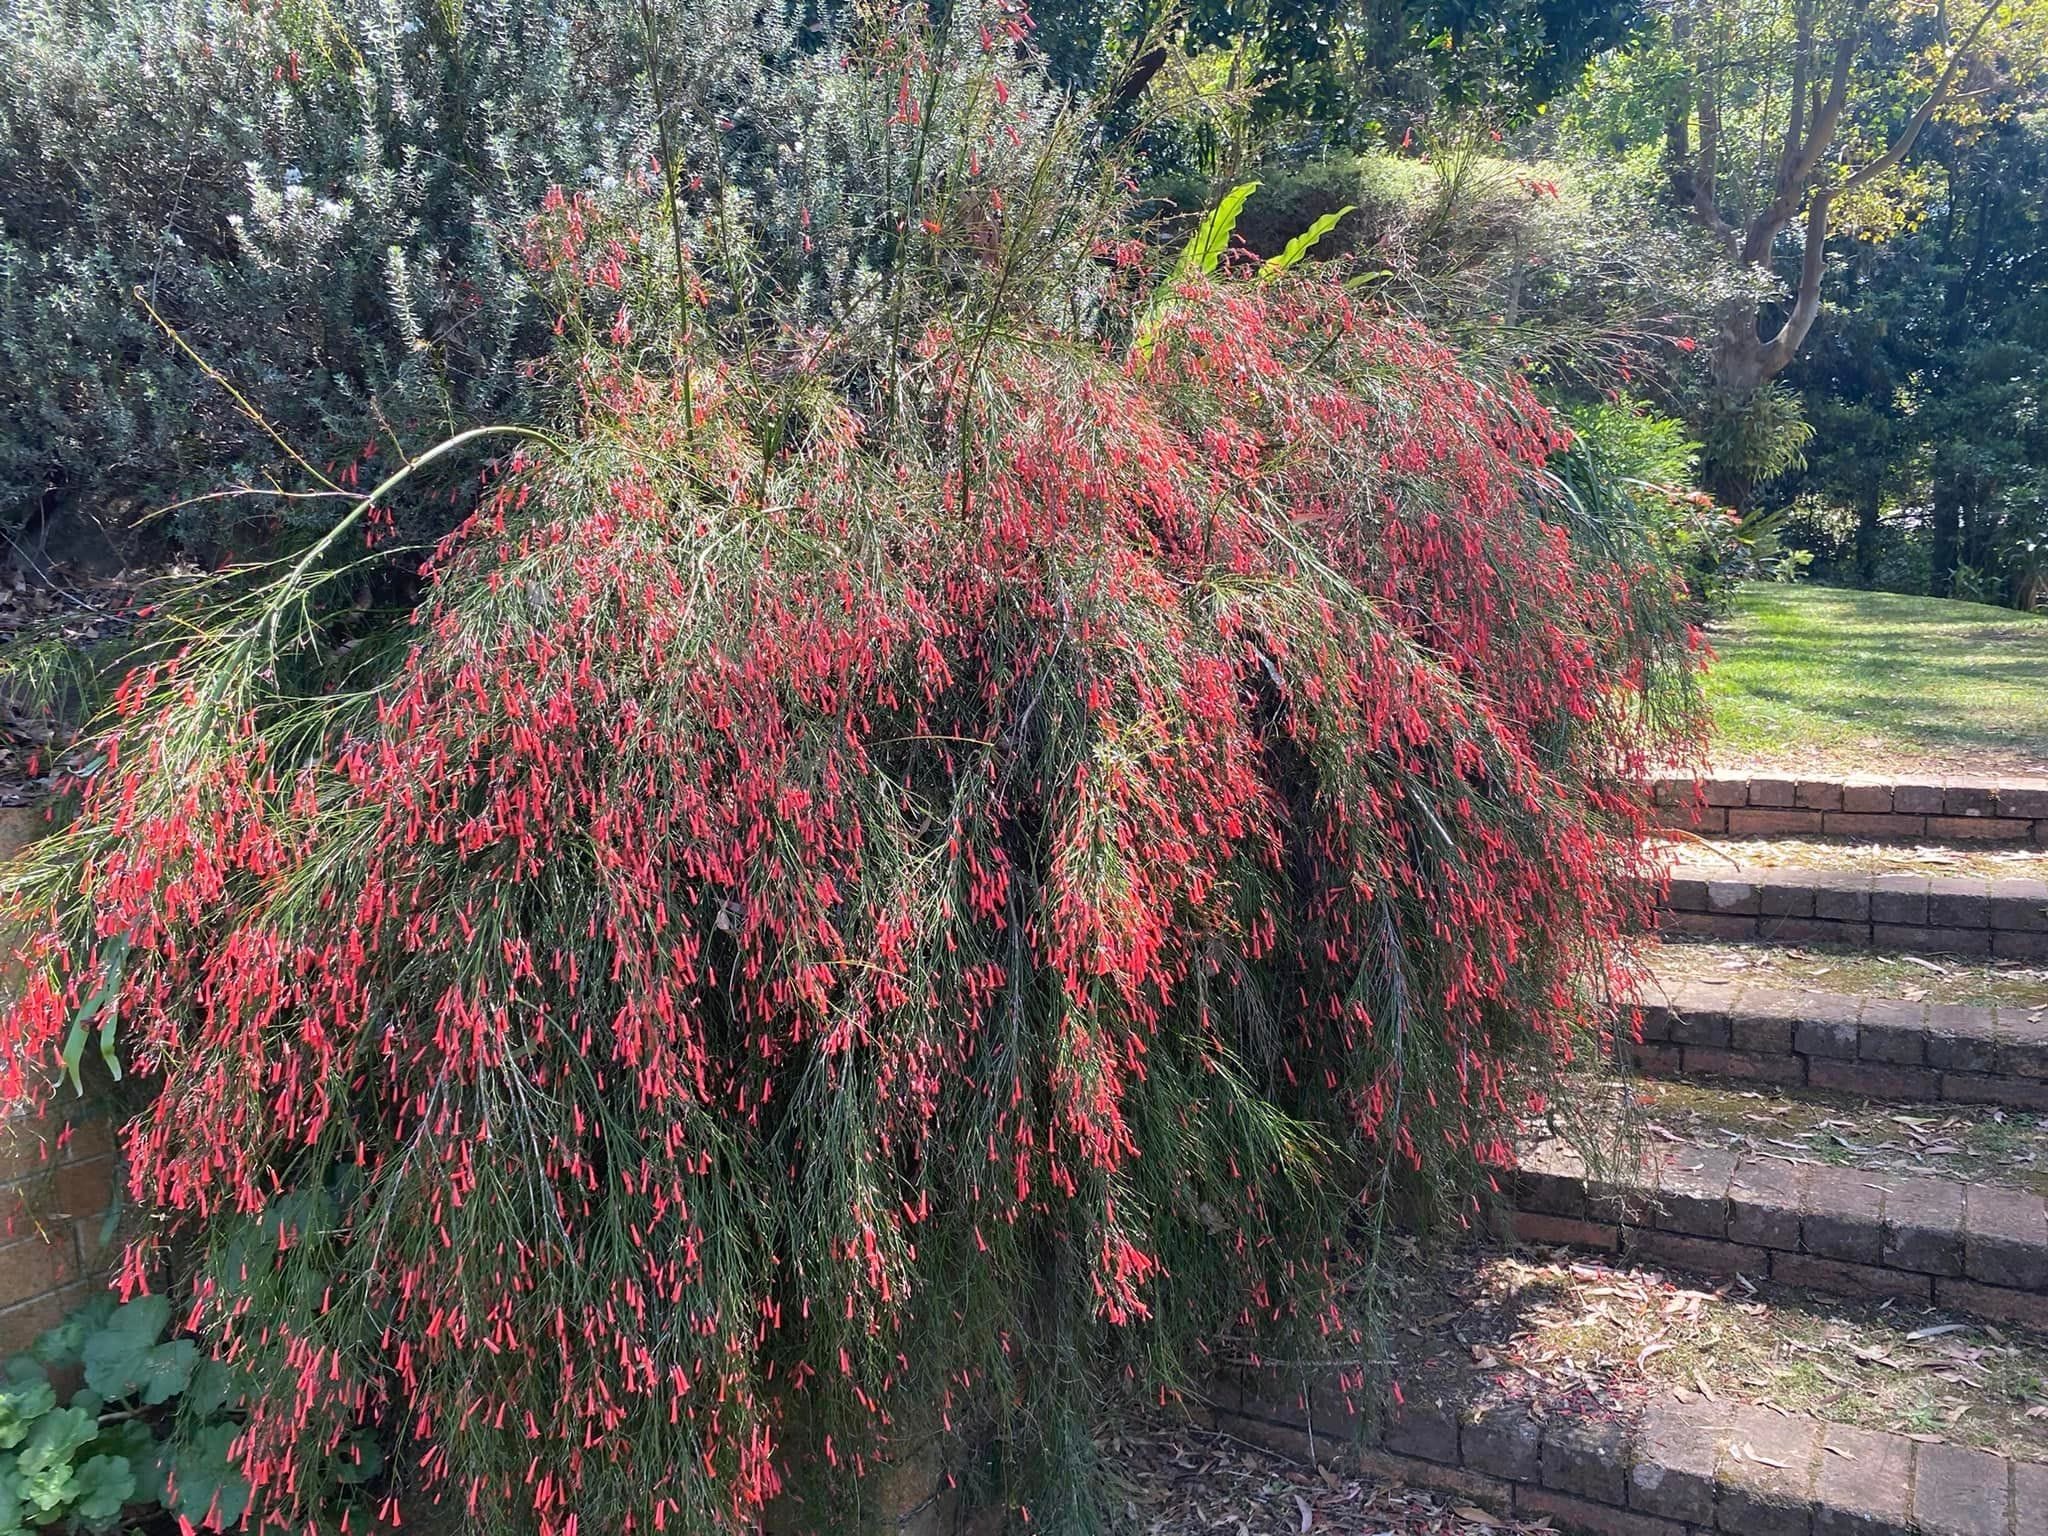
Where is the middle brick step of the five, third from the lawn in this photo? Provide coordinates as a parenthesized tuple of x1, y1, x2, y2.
(1626, 981, 2048, 1110)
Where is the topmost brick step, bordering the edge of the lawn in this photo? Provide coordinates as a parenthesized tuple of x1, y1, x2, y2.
(1651, 774, 2048, 848)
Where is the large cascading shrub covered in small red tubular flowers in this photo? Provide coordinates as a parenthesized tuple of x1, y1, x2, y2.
(6, 6, 1690, 1536)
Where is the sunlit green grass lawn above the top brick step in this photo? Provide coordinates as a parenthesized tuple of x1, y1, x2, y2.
(1706, 586, 2048, 774)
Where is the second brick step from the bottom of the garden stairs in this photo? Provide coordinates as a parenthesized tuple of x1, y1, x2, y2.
(1509, 1141, 2048, 1329)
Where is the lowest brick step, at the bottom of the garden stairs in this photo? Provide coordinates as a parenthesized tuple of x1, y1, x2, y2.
(1212, 1378, 2048, 1536)
